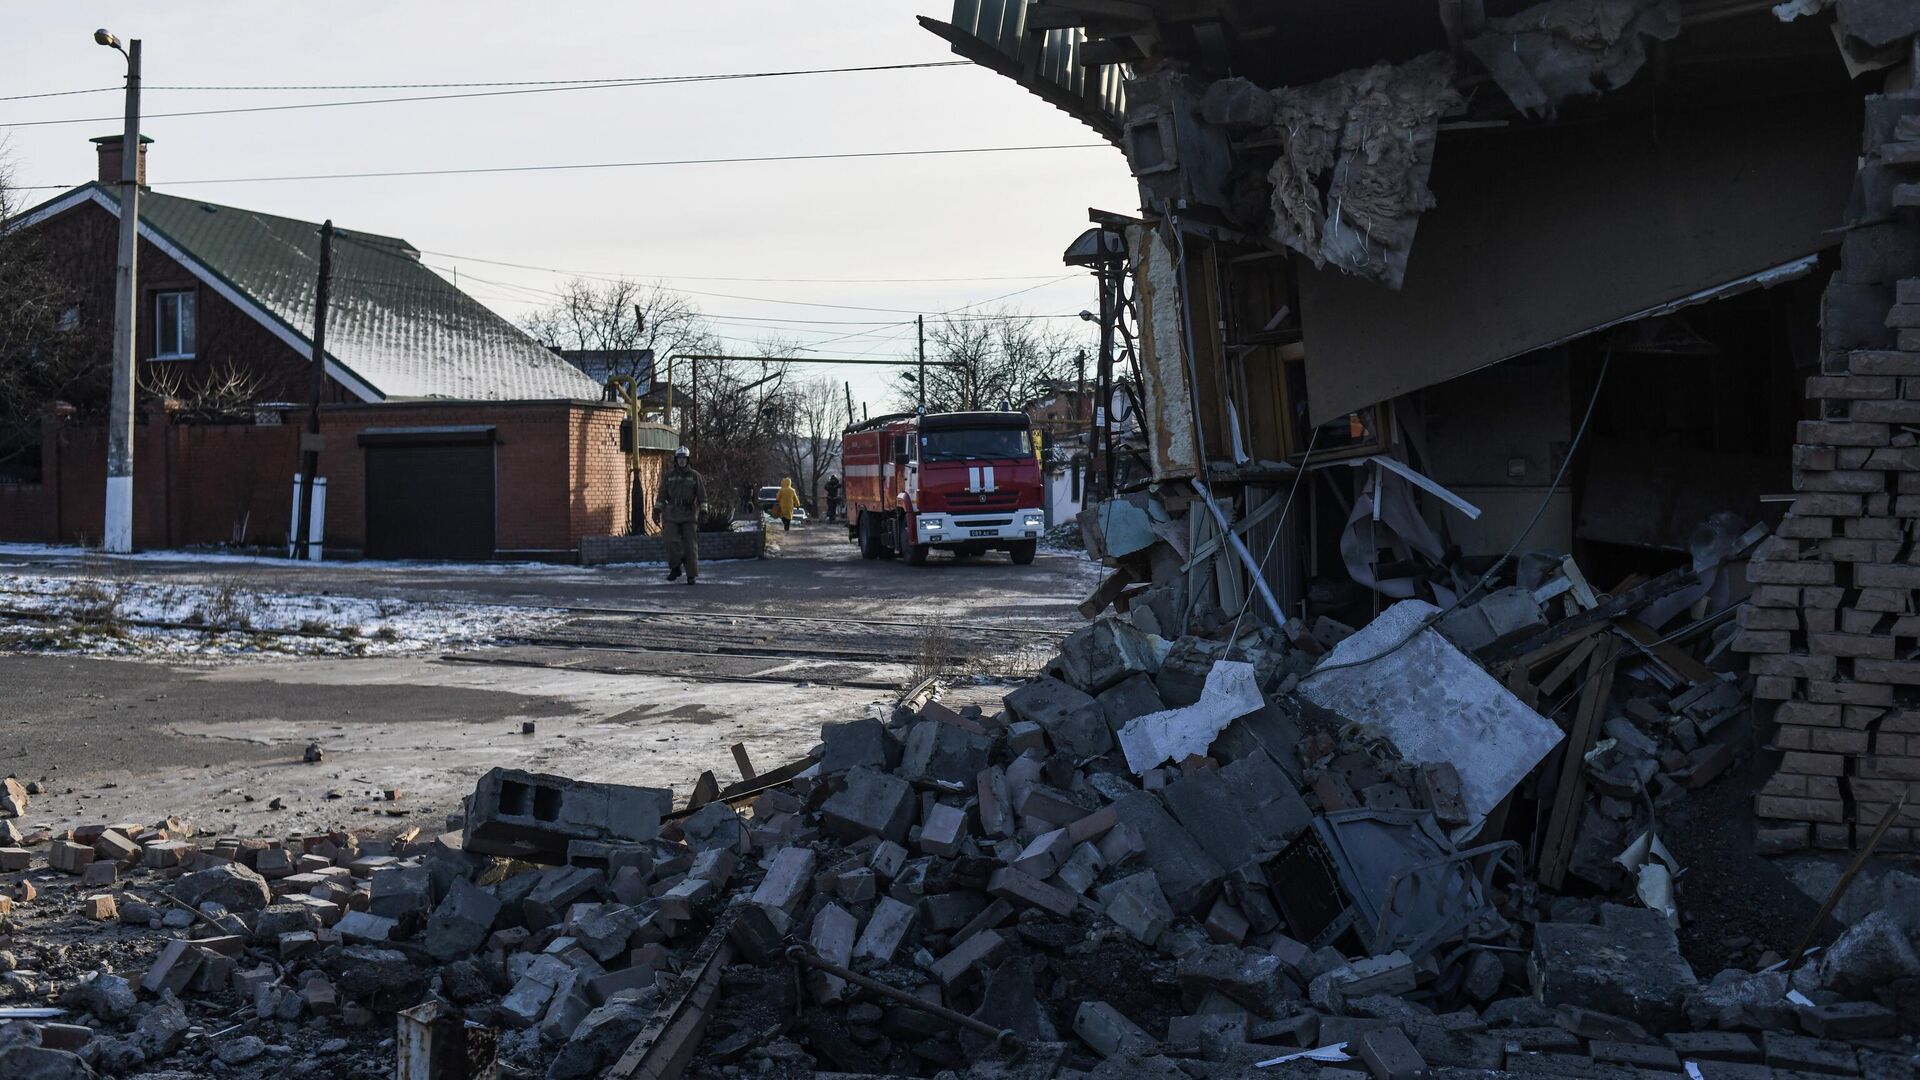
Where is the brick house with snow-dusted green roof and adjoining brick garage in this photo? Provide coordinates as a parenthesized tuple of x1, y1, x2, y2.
(0, 138, 678, 557)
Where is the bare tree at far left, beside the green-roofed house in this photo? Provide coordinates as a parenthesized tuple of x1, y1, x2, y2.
(0, 158, 111, 479)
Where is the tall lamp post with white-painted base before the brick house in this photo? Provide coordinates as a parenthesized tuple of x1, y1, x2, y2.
(94, 29, 140, 553)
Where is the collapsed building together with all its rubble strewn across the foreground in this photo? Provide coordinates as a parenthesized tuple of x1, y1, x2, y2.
(0, 0, 1920, 1080)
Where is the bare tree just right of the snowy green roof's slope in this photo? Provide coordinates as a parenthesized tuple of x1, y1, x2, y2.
(524, 277, 718, 379)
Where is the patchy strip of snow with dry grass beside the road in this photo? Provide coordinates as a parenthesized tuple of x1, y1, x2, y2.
(0, 561, 563, 657)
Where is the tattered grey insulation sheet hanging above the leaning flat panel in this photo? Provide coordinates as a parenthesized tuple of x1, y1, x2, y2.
(1267, 52, 1461, 288)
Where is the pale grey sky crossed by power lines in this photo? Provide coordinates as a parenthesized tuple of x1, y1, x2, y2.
(0, 0, 1137, 409)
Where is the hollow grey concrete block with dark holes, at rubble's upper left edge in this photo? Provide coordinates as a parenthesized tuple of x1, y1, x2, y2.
(461, 769, 660, 865)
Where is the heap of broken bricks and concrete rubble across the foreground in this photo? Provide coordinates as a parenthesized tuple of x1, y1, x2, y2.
(0, 605, 1920, 1080)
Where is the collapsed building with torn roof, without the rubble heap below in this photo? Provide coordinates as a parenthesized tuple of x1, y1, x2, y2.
(922, 0, 1920, 851)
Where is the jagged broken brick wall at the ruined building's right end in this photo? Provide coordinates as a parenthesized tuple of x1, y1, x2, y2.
(1736, 92, 1920, 851)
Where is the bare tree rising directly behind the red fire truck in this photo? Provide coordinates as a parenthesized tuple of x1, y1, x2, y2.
(893, 309, 1087, 413)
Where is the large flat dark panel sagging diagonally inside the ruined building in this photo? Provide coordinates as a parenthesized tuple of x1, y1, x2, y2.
(1300, 92, 1860, 423)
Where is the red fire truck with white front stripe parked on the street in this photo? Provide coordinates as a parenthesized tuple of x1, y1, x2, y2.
(841, 413, 1046, 567)
